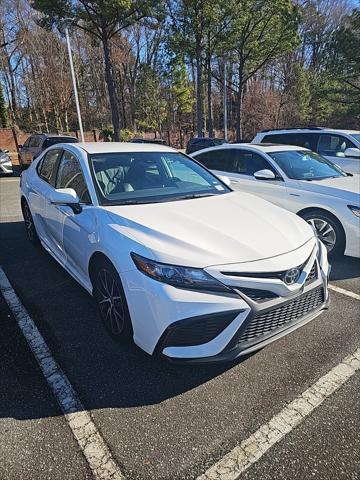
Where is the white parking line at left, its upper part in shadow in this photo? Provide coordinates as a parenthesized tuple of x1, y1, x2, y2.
(0, 267, 124, 480)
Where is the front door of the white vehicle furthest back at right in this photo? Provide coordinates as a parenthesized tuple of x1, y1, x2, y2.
(316, 133, 360, 173)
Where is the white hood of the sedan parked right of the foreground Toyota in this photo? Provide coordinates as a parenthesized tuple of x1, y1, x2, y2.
(301, 174, 360, 204)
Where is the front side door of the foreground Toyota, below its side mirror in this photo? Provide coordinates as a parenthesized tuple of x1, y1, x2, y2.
(46, 150, 95, 276)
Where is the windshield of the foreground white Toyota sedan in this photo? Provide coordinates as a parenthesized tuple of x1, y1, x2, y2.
(89, 152, 231, 205)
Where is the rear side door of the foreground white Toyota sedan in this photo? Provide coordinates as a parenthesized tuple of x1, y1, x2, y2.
(28, 149, 62, 246)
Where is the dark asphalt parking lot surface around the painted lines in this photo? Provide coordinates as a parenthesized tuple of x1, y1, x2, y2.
(0, 173, 360, 480)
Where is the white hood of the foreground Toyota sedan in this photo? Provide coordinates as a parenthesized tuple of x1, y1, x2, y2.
(102, 192, 314, 268)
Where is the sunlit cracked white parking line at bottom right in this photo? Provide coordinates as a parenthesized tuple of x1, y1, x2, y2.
(197, 348, 360, 480)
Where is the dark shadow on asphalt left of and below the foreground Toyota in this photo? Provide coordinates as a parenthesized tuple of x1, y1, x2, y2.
(0, 222, 250, 418)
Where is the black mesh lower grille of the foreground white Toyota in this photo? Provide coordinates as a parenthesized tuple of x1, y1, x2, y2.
(237, 287, 324, 344)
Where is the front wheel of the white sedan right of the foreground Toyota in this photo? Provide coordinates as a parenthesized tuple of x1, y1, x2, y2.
(302, 210, 345, 259)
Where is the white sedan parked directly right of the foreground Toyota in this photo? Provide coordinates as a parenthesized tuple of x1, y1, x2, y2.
(193, 143, 360, 257)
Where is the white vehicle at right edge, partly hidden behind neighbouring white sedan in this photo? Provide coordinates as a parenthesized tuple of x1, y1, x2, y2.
(252, 127, 360, 174)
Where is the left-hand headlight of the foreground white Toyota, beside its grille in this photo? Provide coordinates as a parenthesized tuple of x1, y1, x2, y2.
(131, 252, 232, 293)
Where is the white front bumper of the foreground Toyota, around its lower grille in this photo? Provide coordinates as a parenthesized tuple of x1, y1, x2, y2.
(125, 240, 330, 363)
